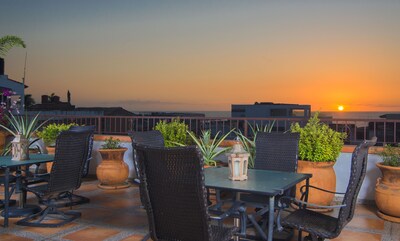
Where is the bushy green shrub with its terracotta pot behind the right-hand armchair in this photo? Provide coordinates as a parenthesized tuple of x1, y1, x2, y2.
(290, 113, 347, 206)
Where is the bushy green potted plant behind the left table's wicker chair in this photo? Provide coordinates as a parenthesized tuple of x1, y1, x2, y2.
(37, 123, 77, 172)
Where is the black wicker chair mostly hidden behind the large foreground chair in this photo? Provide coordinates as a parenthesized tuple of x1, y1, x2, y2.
(128, 130, 164, 183)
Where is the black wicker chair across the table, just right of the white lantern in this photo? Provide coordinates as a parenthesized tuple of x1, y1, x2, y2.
(240, 132, 299, 240)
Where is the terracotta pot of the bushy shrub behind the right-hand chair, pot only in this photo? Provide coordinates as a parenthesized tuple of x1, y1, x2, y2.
(296, 160, 336, 212)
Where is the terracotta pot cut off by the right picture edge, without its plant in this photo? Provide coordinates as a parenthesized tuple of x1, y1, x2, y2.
(375, 163, 400, 223)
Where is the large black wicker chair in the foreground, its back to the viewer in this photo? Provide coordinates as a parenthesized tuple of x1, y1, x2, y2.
(136, 145, 245, 241)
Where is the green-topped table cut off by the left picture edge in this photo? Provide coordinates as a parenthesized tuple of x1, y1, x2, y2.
(0, 154, 54, 227)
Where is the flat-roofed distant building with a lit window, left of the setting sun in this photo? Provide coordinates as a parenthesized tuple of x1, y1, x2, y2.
(231, 102, 311, 118)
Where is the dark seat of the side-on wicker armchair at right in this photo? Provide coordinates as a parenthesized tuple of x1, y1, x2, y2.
(282, 209, 339, 238)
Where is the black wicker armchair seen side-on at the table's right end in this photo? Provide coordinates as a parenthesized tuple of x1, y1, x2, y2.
(277, 137, 376, 241)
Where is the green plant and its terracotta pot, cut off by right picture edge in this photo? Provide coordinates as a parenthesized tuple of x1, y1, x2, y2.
(375, 145, 400, 223)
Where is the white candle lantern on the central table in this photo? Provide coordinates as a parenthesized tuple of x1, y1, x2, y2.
(227, 141, 250, 181)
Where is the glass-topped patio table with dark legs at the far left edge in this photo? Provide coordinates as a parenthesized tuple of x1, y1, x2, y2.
(0, 154, 54, 228)
